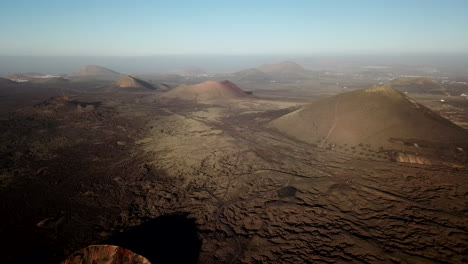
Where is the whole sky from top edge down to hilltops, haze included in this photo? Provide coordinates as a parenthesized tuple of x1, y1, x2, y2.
(0, 0, 468, 76)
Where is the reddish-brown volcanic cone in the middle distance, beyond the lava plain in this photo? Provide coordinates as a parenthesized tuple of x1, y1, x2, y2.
(162, 80, 248, 102)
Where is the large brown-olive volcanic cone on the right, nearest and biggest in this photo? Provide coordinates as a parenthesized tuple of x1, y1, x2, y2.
(270, 86, 468, 163)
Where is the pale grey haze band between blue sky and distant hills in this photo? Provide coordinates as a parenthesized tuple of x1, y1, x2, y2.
(0, 55, 468, 76)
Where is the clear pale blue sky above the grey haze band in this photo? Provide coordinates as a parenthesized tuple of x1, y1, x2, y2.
(0, 0, 468, 56)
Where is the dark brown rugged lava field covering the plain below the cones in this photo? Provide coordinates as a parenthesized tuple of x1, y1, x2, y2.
(0, 77, 468, 263)
